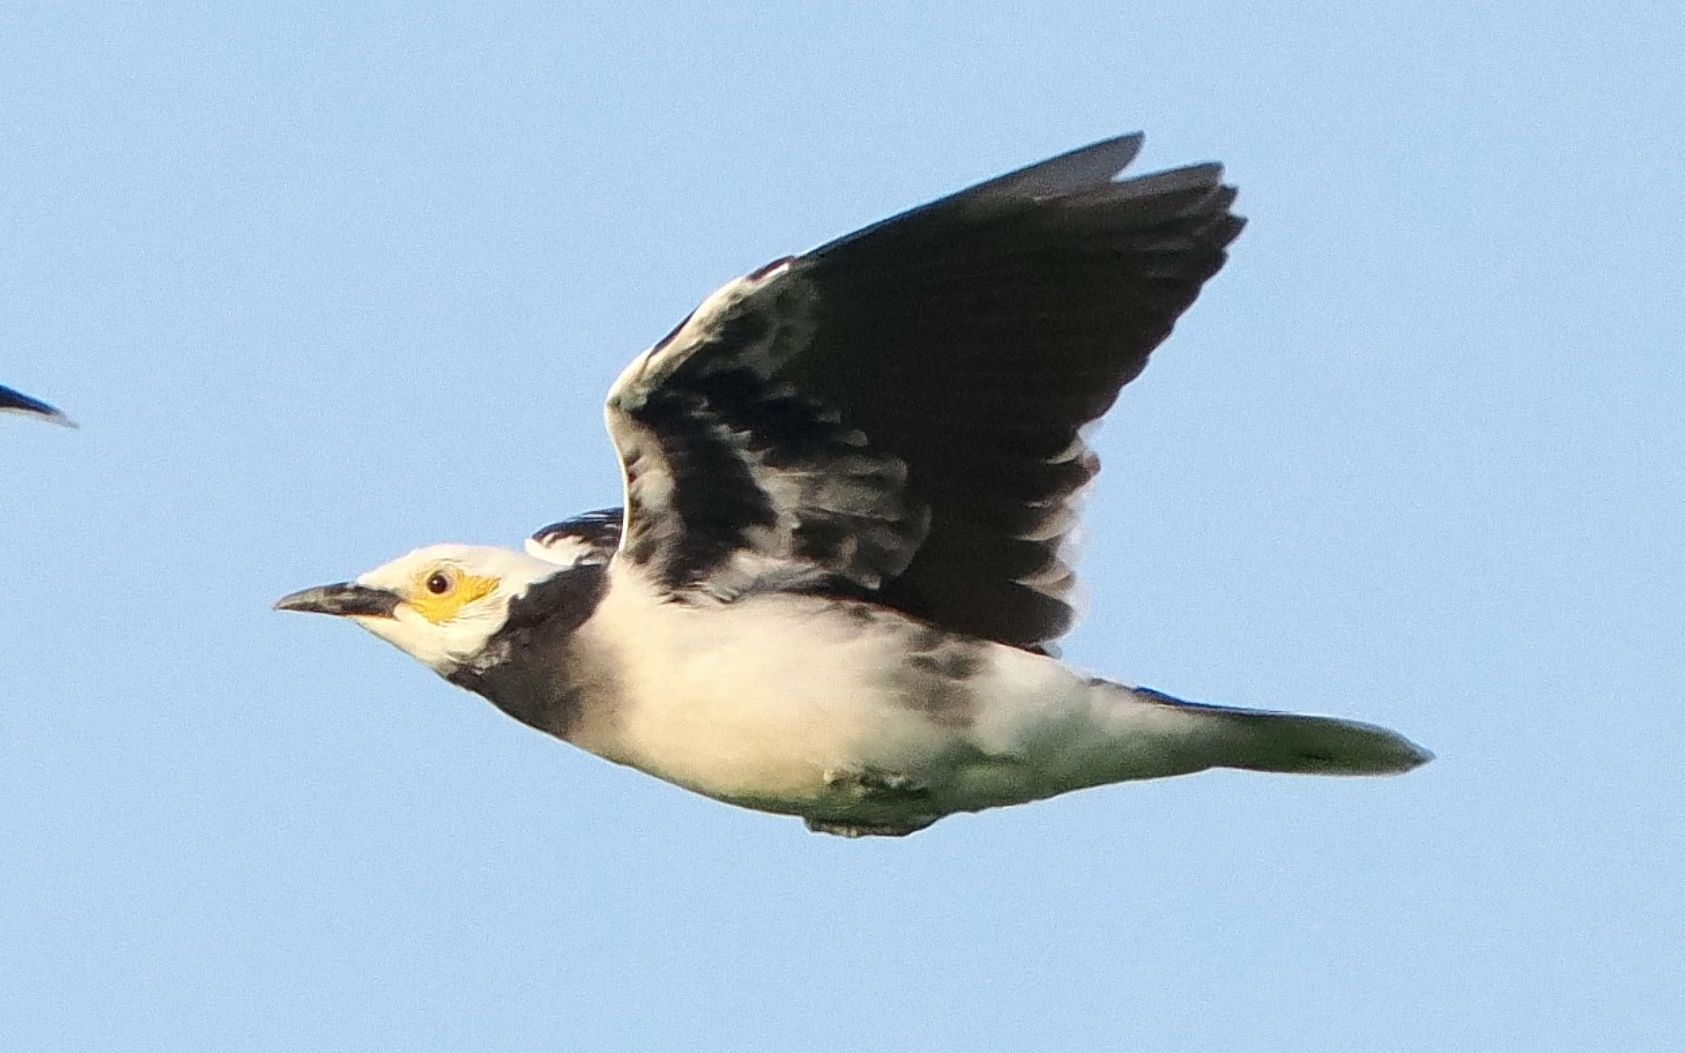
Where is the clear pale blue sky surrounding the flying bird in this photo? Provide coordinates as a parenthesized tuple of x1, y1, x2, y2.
(0, 0, 1685, 1051)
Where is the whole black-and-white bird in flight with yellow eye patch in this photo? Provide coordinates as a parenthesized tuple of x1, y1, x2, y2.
(276, 135, 1431, 836)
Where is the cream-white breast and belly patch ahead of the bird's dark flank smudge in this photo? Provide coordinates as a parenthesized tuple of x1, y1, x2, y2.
(573, 590, 957, 810)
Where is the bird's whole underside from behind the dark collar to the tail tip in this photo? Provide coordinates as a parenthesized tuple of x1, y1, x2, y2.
(535, 566, 1424, 832)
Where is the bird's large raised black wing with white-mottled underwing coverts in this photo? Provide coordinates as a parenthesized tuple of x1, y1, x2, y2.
(607, 135, 1242, 647)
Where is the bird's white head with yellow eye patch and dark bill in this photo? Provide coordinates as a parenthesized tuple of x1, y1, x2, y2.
(275, 544, 571, 676)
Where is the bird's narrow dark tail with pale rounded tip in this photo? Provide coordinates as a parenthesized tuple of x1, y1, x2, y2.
(1107, 684, 1434, 775)
